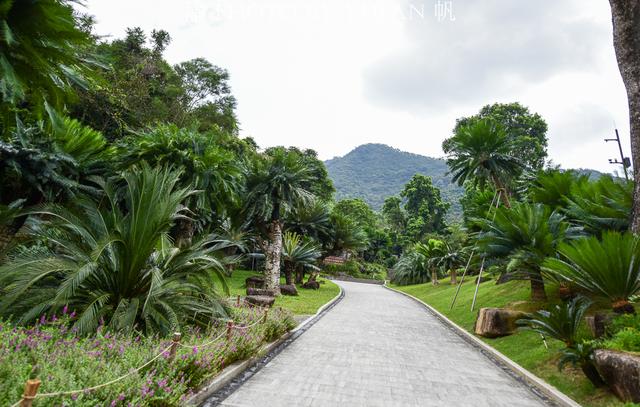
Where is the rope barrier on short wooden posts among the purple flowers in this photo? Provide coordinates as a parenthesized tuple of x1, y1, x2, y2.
(10, 312, 267, 407)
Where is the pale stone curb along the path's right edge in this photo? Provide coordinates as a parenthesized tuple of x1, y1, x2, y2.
(383, 283, 582, 407)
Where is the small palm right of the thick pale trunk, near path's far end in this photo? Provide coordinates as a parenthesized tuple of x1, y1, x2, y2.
(282, 232, 322, 285)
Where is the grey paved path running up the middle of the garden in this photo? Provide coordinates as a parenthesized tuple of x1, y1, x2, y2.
(212, 282, 545, 407)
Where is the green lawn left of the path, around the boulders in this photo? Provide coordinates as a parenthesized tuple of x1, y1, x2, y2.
(227, 270, 340, 315)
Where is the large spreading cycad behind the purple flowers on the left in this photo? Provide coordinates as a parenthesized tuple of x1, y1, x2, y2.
(0, 165, 226, 335)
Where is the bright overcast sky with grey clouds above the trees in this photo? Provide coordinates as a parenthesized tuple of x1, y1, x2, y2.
(86, 0, 629, 171)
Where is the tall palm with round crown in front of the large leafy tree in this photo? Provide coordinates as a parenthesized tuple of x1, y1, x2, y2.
(445, 119, 523, 207)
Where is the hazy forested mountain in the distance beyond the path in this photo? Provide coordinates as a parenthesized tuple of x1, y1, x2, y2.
(325, 144, 463, 216)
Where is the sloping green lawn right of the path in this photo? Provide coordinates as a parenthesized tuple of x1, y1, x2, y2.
(392, 278, 624, 407)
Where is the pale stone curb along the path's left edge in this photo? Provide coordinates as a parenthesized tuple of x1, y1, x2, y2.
(185, 283, 344, 406)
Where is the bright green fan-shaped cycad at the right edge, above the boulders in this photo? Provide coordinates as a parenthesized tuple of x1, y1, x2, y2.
(543, 232, 640, 313)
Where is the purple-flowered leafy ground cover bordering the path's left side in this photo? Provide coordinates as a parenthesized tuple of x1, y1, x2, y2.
(0, 307, 295, 406)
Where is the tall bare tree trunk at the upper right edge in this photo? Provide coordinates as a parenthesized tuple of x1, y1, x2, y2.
(609, 0, 640, 233)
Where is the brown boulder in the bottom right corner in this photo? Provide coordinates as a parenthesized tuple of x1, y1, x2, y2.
(593, 349, 640, 403)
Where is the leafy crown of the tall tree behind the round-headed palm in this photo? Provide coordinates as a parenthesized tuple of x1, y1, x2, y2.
(442, 102, 548, 170)
